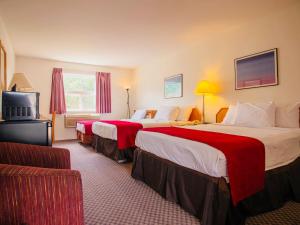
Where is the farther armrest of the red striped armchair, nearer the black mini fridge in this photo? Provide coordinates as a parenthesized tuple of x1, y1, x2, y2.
(0, 142, 71, 169)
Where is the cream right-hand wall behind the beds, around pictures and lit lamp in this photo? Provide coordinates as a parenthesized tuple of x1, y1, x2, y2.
(135, 4, 300, 121)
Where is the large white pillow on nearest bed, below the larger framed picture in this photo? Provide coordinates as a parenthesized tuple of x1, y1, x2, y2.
(234, 102, 275, 127)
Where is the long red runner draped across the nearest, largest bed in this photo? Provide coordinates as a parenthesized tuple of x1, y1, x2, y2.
(143, 127, 265, 205)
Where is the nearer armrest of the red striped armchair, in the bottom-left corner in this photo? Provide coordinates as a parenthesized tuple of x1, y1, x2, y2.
(0, 164, 84, 225)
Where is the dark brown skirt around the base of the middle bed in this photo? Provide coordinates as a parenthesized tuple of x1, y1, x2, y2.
(93, 135, 134, 163)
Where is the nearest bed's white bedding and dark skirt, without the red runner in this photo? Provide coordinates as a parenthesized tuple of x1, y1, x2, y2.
(132, 107, 300, 225)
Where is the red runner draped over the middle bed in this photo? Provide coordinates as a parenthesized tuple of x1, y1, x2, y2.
(101, 120, 143, 150)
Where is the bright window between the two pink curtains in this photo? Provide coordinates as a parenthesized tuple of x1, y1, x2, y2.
(63, 73, 96, 113)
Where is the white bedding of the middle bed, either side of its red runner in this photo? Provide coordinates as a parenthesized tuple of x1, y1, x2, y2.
(92, 119, 191, 140)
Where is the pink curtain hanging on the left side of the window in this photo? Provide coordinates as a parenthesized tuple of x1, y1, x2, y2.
(50, 68, 66, 114)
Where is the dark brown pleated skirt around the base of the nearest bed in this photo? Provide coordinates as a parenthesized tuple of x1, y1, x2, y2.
(132, 148, 300, 225)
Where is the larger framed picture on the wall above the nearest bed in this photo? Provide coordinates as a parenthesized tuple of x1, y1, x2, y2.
(234, 48, 278, 90)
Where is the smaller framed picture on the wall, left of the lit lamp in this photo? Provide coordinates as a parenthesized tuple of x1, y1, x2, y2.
(165, 74, 183, 98)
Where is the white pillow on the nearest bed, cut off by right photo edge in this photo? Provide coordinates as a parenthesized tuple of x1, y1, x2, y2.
(276, 102, 300, 128)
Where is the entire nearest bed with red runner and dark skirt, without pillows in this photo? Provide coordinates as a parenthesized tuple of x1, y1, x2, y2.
(132, 124, 300, 225)
